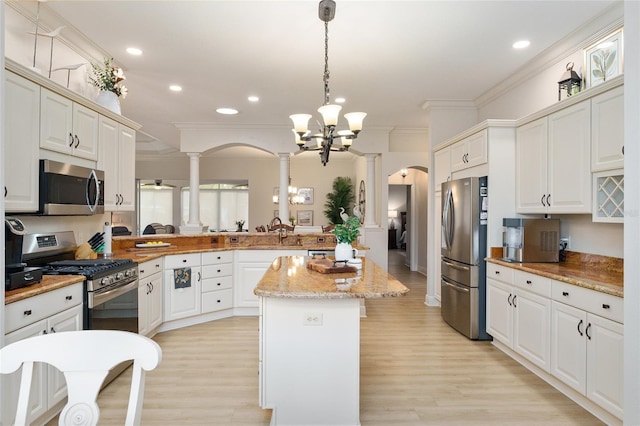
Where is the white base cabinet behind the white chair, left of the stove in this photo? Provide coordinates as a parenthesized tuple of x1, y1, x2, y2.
(2, 283, 82, 425)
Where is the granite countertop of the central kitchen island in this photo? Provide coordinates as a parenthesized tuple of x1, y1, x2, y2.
(253, 256, 409, 299)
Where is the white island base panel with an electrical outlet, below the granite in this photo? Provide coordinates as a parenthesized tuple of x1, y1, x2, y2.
(259, 297, 360, 426)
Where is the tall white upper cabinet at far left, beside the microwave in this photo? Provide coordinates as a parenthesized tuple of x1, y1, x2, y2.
(4, 71, 40, 212)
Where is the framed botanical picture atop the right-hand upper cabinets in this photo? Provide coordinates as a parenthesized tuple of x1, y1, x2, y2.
(584, 28, 623, 88)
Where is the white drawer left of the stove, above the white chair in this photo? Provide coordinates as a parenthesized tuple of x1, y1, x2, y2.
(4, 283, 83, 334)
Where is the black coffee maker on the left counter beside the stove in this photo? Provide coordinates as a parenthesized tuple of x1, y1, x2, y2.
(4, 217, 42, 291)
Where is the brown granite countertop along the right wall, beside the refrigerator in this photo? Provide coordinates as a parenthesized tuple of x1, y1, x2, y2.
(485, 252, 624, 297)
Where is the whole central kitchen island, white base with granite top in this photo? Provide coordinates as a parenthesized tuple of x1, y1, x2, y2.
(254, 256, 409, 426)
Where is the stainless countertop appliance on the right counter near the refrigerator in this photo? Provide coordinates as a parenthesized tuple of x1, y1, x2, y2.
(502, 218, 560, 263)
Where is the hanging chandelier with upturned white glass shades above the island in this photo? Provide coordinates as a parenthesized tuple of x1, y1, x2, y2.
(289, 0, 367, 166)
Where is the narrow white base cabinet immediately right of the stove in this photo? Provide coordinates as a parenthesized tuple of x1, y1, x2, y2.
(138, 258, 164, 336)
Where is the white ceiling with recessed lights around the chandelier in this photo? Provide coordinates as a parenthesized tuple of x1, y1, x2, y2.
(45, 0, 613, 153)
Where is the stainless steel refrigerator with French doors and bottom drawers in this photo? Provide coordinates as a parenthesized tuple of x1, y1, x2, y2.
(440, 176, 491, 340)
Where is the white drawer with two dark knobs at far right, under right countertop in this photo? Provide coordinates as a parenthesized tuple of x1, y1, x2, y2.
(551, 281, 624, 323)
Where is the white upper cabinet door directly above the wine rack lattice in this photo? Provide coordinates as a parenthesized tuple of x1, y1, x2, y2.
(591, 86, 624, 172)
